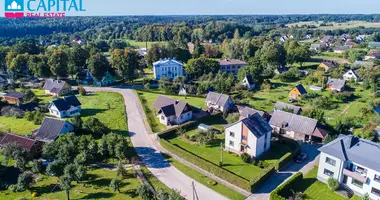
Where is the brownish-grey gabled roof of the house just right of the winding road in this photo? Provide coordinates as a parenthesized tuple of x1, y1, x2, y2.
(153, 95, 191, 116)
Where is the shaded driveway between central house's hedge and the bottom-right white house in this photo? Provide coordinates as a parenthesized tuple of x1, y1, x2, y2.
(247, 144, 319, 200)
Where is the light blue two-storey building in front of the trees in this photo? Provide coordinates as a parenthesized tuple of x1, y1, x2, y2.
(153, 59, 184, 80)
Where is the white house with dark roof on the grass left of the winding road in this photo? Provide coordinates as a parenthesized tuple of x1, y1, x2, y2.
(49, 95, 82, 118)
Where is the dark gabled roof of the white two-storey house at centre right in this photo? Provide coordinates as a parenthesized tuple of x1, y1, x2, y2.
(226, 113, 272, 138)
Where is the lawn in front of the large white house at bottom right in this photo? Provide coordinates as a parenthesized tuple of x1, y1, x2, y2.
(293, 167, 360, 200)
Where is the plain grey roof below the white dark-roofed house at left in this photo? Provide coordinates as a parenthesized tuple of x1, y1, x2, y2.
(35, 117, 68, 141)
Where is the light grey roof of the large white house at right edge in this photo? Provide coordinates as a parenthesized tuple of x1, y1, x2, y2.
(318, 135, 380, 172)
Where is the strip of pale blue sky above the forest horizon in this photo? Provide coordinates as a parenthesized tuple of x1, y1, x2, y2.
(0, 0, 380, 15)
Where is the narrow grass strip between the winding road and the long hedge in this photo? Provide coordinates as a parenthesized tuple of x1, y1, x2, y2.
(164, 155, 246, 200)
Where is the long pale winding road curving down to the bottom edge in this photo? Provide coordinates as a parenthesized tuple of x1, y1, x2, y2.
(81, 87, 228, 200)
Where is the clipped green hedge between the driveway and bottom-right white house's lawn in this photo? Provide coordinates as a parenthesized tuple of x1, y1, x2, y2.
(269, 172, 303, 200)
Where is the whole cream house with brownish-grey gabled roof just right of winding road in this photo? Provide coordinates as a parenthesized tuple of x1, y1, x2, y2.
(153, 95, 193, 125)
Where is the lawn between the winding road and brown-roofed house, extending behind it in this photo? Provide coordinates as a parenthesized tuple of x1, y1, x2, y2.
(137, 90, 205, 132)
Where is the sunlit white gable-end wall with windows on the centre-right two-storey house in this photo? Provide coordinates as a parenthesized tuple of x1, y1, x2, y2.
(224, 122, 242, 154)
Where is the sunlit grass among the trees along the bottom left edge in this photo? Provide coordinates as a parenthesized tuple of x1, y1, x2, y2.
(0, 169, 140, 200)
